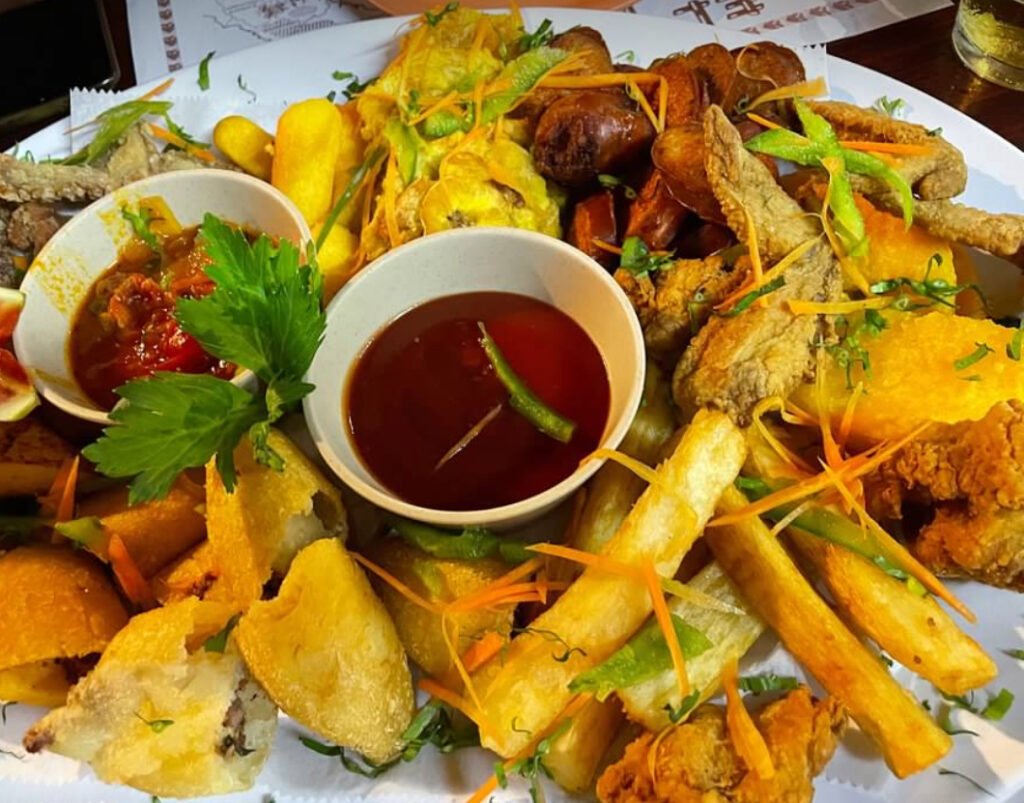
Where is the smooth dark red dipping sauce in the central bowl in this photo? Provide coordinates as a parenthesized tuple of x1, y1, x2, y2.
(342, 292, 610, 510)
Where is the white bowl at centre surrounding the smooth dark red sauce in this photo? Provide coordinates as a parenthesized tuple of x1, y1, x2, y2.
(304, 228, 644, 529)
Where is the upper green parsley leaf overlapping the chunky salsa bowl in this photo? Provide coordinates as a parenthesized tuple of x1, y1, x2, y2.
(177, 214, 327, 385)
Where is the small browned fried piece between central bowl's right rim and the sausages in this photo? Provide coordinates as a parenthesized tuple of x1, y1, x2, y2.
(615, 254, 749, 360)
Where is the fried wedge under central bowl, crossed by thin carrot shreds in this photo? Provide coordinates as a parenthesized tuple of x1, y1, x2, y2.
(367, 539, 513, 677)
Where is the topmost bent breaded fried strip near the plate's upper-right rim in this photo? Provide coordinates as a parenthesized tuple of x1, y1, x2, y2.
(808, 100, 967, 201)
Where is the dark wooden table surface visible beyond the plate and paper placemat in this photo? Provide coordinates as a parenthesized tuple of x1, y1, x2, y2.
(0, 0, 1024, 149)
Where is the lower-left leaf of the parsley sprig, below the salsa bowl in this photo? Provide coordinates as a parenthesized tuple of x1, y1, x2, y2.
(82, 373, 266, 505)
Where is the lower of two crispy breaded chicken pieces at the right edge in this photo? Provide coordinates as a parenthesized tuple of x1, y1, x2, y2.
(912, 505, 1024, 592)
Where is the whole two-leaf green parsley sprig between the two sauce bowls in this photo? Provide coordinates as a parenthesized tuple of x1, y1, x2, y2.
(83, 214, 327, 504)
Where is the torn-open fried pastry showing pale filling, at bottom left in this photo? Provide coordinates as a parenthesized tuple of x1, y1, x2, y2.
(25, 598, 278, 797)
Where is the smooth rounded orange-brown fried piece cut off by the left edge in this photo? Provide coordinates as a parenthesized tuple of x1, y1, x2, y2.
(0, 546, 128, 706)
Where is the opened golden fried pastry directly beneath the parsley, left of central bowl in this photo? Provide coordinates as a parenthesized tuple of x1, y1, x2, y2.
(206, 430, 347, 608)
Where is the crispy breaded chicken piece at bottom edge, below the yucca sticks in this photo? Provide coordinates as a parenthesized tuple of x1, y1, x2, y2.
(597, 686, 846, 803)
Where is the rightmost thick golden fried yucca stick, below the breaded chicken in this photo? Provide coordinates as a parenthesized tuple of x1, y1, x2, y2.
(788, 527, 998, 694)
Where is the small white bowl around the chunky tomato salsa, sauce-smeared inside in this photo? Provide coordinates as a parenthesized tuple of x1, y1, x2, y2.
(14, 170, 312, 424)
